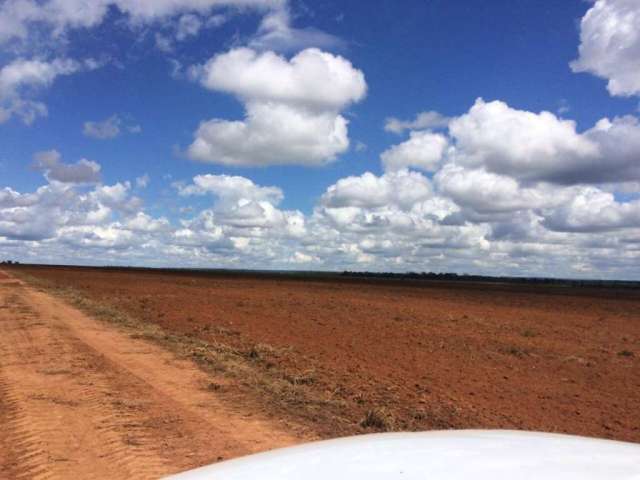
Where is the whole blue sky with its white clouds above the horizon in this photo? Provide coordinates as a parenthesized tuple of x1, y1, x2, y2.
(0, 0, 640, 280)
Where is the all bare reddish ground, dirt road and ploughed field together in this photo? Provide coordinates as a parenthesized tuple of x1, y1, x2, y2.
(0, 266, 640, 478)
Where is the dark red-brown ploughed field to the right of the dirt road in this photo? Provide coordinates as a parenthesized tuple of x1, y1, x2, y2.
(11, 268, 640, 442)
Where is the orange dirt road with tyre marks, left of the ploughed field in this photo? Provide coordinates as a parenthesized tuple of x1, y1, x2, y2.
(0, 271, 300, 479)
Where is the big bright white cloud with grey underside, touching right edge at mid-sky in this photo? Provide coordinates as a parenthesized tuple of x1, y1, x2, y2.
(392, 99, 640, 185)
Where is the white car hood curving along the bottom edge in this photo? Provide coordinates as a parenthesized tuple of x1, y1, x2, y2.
(170, 430, 640, 480)
